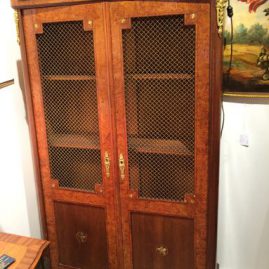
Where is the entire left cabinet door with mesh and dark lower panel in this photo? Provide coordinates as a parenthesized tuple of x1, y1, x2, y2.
(23, 4, 118, 269)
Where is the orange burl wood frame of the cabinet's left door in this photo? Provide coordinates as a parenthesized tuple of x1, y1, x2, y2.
(23, 3, 118, 269)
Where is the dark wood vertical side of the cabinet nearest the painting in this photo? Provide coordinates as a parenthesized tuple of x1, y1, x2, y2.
(206, 0, 222, 269)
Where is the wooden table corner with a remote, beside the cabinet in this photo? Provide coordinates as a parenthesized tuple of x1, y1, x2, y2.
(0, 233, 49, 269)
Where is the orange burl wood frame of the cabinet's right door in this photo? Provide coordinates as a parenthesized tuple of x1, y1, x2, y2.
(110, 1, 210, 269)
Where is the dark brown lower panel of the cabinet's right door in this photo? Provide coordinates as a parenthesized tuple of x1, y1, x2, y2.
(131, 213, 194, 269)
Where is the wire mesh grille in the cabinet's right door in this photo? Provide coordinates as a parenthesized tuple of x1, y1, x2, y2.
(123, 15, 195, 201)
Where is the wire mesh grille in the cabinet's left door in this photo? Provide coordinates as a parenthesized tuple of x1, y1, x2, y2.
(37, 21, 102, 191)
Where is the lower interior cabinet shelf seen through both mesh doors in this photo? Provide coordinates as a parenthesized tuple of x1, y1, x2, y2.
(50, 134, 192, 156)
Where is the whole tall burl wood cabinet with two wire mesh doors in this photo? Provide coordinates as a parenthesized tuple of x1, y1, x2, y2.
(12, 0, 221, 269)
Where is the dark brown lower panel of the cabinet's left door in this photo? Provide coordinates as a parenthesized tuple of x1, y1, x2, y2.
(54, 202, 108, 269)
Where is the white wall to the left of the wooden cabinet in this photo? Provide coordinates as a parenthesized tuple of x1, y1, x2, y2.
(0, 0, 41, 237)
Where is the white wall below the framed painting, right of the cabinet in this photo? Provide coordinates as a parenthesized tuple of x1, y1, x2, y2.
(218, 102, 269, 269)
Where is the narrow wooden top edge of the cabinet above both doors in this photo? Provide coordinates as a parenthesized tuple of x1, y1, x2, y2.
(11, 0, 209, 9)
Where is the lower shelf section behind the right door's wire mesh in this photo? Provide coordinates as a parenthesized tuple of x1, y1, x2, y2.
(128, 138, 193, 156)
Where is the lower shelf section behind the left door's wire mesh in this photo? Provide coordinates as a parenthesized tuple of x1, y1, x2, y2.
(50, 134, 100, 150)
